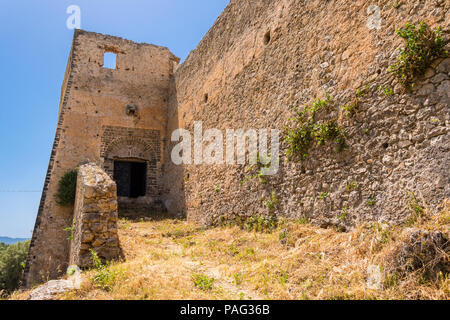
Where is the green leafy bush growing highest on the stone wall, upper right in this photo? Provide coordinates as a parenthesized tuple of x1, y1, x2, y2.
(389, 21, 448, 89)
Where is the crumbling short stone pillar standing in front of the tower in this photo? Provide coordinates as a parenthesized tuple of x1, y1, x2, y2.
(70, 163, 120, 268)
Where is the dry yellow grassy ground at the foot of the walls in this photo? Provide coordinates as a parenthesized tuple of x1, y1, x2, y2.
(8, 202, 450, 299)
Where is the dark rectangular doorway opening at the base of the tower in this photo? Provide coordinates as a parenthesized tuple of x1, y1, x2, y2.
(114, 161, 147, 198)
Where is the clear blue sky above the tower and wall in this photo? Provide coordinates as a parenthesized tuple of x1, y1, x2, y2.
(0, 0, 229, 237)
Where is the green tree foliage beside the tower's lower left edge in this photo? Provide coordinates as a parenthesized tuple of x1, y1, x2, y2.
(0, 241, 30, 292)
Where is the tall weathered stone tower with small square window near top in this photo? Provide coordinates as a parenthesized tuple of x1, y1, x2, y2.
(25, 30, 179, 286)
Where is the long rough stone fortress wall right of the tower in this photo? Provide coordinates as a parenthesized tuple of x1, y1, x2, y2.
(165, 0, 450, 228)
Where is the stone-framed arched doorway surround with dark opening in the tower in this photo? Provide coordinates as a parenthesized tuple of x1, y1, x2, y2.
(101, 127, 164, 217)
